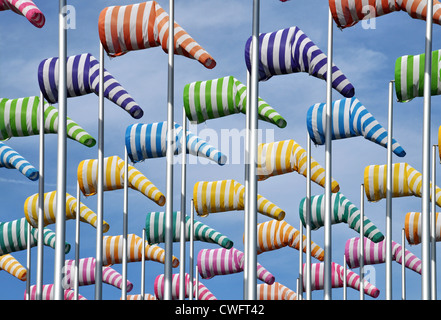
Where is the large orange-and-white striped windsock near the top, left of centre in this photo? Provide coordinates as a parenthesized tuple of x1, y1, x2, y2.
(98, 1, 216, 69)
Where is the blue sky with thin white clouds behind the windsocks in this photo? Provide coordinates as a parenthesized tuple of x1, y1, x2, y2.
(0, 0, 441, 300)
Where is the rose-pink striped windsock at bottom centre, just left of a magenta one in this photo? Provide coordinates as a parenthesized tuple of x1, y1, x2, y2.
(154, 273, 217, 300)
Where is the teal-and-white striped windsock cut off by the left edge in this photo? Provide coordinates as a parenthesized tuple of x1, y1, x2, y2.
(0, 218, 70, 255)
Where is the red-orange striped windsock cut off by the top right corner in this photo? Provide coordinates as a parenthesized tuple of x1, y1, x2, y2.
(329, 0, 441, 29)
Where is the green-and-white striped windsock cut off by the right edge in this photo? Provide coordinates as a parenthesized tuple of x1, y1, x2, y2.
(395, 50, 441, 102)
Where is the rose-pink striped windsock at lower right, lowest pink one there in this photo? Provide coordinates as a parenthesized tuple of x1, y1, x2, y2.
(303, 262, 380, 298)
